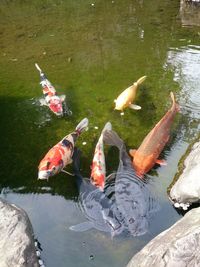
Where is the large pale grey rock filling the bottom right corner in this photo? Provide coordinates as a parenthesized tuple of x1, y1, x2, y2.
(127, 208, 200, 267)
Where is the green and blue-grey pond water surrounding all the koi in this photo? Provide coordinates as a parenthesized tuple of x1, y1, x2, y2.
(0, 0, 200, 267)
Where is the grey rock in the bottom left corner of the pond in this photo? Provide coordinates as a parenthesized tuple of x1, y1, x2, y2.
(0, 198, 39, 267)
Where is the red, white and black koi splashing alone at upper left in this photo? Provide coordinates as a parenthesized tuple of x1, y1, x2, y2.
(35, 63, 71, 116)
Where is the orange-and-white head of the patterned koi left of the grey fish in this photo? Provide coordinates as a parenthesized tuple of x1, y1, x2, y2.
(38, 159, 63, 180)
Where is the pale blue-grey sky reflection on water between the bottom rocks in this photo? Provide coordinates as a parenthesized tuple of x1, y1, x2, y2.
(1, 193, 156, 267)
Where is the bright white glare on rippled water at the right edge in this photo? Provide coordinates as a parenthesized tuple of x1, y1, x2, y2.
(167, 45, 200, 139)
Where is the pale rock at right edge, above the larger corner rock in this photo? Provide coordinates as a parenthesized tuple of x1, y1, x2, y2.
(169, 142, 200, 209)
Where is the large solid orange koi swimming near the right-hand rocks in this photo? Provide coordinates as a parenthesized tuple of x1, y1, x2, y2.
(129, 92, 180, 178)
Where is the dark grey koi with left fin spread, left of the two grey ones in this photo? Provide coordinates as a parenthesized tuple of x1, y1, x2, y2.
(70, 148, 123, 237)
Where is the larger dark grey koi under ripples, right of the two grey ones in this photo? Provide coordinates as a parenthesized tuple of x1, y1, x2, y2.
(104, 130, 159, 236)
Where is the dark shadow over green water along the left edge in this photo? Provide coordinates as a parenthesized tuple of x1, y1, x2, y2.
(0, 97, 77, 199)
